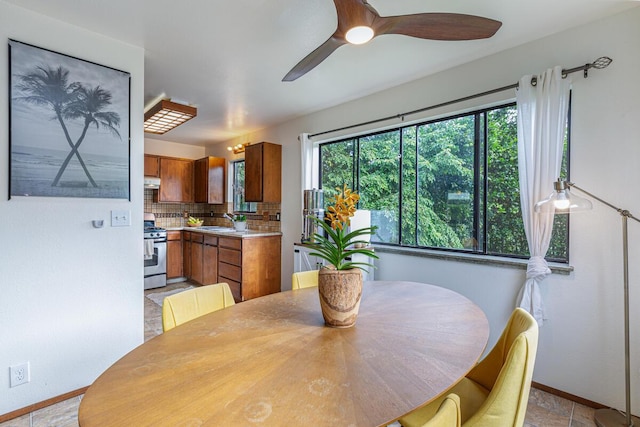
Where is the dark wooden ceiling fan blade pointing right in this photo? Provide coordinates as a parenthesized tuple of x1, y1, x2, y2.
(374, 13, 502, 40)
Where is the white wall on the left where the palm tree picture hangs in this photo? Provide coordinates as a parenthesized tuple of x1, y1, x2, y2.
(0, 1, 144, 414)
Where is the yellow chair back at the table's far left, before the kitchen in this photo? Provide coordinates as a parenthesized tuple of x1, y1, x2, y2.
(162, 283, 235, 332)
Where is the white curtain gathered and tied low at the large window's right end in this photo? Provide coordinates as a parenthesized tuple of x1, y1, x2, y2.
(516, 66, 571, 326)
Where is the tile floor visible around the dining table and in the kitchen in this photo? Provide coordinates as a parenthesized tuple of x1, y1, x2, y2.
(0, 282, 595, 427)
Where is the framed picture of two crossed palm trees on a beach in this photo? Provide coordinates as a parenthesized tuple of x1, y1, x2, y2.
(9, 40, 131, 200)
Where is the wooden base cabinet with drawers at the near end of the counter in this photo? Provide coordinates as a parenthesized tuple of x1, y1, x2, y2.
(218, 236, 281, 302)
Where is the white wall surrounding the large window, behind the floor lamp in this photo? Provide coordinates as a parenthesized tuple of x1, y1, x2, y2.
(216, 8, 640, 414)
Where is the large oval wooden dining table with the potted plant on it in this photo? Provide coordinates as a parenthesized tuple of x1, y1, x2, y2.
(78, 281, 489, 427)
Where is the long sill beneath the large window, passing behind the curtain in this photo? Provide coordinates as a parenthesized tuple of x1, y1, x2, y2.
(374, 245, 573, 275)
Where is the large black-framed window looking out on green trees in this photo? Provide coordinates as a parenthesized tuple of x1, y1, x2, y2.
(320, 104, 568, 262)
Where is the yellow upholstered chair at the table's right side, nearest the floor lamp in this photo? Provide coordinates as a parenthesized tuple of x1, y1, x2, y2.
(400, 308, 538, 427)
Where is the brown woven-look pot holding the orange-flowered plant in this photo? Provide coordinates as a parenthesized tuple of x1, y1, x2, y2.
(318, 268, 362, 328)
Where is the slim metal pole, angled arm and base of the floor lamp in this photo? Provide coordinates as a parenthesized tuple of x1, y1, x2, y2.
(566, 182, 640, 427)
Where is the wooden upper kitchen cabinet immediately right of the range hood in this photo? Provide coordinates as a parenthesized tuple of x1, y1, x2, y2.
(157, 157, 194, 203)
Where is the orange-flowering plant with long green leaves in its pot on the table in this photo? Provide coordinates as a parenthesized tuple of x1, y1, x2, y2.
(309, 185, 378, 328)
